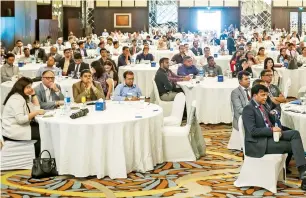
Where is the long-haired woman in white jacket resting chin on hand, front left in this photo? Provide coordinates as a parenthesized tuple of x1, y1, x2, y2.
(2, 77, 44, 157)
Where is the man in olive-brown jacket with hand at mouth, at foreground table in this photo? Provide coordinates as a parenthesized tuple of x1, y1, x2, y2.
(72, 69, 105, 103)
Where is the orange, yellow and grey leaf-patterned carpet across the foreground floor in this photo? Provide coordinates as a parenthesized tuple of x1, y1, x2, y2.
(1, 125, 306, 198)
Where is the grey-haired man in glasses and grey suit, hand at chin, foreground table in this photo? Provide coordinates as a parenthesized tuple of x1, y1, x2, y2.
(34, 70, 64, 110)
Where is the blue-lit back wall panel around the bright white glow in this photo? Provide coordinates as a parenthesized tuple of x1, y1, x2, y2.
(178, 7, 240, 32)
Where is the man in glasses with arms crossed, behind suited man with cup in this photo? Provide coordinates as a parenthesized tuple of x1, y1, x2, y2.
(260, 69, 286, 105)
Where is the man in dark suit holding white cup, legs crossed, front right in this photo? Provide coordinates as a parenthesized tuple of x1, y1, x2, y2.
(242, 85, 306, 190)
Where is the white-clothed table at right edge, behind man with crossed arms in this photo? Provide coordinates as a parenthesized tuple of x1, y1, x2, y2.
(252, 65, 306, 97)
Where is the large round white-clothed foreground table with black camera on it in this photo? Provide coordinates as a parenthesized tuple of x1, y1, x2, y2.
(37, 102, 163, 179)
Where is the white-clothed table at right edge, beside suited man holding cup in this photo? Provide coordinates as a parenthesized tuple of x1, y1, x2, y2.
(281, 103, 306, 150)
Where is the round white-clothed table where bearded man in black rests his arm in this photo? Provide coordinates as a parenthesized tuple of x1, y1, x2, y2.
(177, 77, 239, 124)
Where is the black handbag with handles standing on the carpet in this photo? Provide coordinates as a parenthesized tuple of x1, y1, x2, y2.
(31, 150, 58, 179)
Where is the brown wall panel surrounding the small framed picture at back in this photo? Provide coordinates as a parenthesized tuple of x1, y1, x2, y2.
(94, 7, 149, 35)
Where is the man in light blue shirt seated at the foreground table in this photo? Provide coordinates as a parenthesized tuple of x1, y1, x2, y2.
(114, 71, 141, 101)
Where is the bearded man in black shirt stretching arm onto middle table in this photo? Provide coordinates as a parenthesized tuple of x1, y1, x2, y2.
(155, 58, 186, 101)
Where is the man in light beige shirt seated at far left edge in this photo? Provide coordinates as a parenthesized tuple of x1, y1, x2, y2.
(1, 53, 19, 82)
